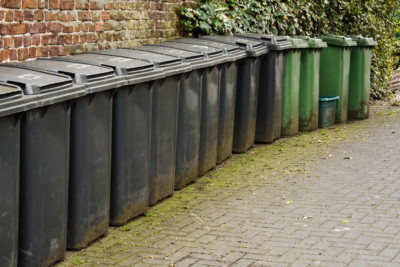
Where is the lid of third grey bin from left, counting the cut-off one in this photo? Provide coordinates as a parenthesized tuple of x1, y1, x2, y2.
(18, 56, 124, 93)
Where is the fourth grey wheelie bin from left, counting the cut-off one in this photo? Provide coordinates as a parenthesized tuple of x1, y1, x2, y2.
(54, 53, 164, 225)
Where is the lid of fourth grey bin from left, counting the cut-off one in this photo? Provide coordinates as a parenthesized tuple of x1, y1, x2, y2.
(56, 53, 164, 87)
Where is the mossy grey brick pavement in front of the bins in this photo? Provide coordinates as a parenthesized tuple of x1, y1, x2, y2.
(59, 107, 400, 267)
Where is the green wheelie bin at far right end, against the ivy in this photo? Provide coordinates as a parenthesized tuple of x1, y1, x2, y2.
(347, 36, 378, 120)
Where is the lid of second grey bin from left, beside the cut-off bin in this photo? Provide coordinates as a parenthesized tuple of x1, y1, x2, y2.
(0, 63, 86, 106)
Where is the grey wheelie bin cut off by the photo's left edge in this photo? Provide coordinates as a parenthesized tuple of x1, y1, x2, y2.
(0, 83, 36, 267)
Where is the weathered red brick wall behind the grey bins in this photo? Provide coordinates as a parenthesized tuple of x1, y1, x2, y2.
(0, 0, 195, 62)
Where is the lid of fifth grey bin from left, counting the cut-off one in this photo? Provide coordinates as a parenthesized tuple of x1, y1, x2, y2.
(93, 48, 192, 76)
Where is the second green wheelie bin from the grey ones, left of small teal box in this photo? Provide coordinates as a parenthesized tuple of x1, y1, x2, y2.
(299, 37, 327, 132)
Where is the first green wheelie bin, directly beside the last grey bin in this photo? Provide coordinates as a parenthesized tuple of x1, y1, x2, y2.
(281, 38, 308, 136)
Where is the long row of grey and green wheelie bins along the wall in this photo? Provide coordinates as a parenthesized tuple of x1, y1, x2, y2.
(0, 34, 374, 266)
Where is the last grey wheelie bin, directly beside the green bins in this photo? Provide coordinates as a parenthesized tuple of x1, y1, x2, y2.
(235, 33, 293, 143)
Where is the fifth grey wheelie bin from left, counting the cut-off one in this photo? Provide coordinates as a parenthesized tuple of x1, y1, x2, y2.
(96, 49, 191, 205)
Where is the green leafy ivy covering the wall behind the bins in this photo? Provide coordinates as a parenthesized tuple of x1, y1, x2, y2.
(179, 0, 400, 98)
